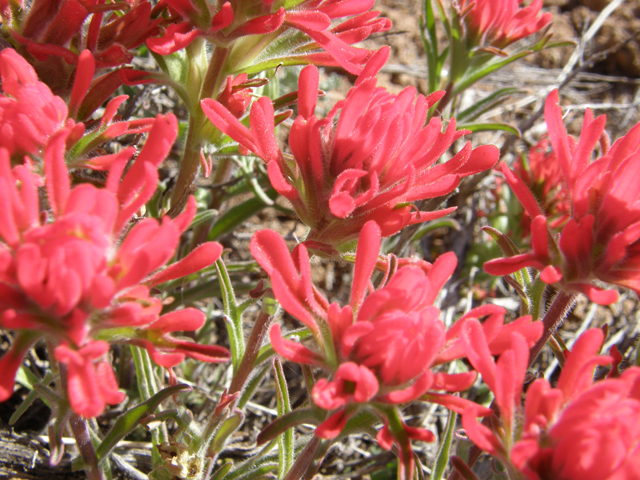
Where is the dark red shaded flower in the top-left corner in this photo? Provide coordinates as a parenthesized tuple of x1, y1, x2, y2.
(0, 0, 163, 93)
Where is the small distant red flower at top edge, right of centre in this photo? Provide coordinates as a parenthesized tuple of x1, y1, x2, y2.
(459, 0, 551, 49)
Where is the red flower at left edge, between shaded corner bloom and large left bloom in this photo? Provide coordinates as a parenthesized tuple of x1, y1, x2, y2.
(0, 48, 154, 167)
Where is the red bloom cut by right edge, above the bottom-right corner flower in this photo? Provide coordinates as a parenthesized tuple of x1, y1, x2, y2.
(485, 91, 640, 304)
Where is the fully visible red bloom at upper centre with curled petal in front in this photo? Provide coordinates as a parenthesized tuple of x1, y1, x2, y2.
(202, 49, 498, 255)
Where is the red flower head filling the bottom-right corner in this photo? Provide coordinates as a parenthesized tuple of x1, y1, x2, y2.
(462, 324, 640, 480)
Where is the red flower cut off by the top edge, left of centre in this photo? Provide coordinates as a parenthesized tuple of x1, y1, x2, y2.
(147, 0, 391, 74)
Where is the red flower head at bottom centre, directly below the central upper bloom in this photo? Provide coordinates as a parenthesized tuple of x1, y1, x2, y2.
(250, 222, 541, 476)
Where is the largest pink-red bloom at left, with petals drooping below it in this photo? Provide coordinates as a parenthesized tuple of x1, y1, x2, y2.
(0, 115, 228, 417)
